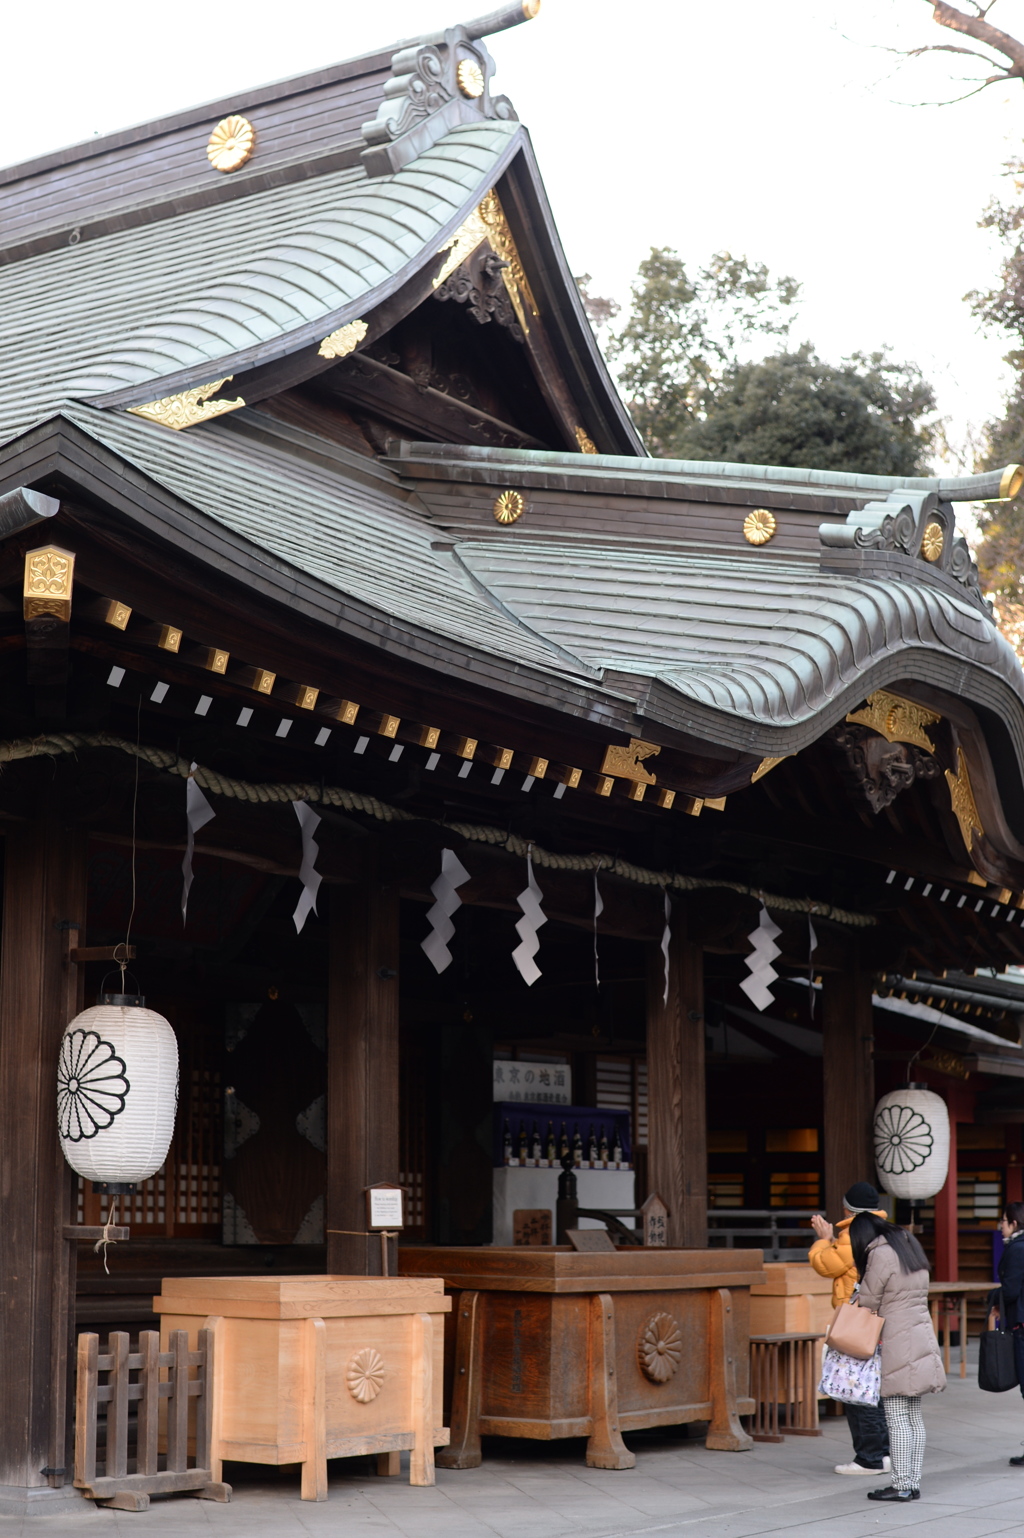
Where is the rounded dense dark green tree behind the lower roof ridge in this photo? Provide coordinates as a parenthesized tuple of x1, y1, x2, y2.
(677, 343, 936, 475)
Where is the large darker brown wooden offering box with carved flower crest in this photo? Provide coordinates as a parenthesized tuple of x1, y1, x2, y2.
(398, 1246, 764, 1469)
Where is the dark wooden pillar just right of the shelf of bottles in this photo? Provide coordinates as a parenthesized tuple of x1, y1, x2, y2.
(647, 906, 707, 1249)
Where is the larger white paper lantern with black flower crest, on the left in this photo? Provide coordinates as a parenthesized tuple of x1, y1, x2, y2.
(57, 994, 178, 1186)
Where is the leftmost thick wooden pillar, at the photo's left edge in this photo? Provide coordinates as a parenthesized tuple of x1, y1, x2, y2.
(0, 817, 86, 1515)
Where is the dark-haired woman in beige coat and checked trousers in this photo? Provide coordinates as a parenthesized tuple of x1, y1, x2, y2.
(850, 1212, 946, 1501)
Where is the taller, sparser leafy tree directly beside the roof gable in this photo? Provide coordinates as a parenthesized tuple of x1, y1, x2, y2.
(607, 246, 800, 458)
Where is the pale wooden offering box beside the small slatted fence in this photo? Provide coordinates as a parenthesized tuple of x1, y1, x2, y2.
(154, 1277, 452, 1501)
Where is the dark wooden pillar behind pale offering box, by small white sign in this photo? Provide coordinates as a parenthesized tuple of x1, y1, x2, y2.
(327, 851, 398, 1277)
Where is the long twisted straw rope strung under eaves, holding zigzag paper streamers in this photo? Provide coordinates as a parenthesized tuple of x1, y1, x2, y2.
(0, 732, 878, 929)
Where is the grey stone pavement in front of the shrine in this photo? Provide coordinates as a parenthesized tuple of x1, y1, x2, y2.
(11, 1350, 1024, 1538)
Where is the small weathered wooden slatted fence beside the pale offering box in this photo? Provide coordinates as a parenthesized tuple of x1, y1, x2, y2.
(75, 1329, 231, 1512)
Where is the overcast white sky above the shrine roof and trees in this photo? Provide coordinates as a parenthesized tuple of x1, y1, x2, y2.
(0, 0, 1024, 457)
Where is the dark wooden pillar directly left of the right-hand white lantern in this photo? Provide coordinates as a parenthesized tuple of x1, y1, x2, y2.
(820, 964, 876, 1223)
